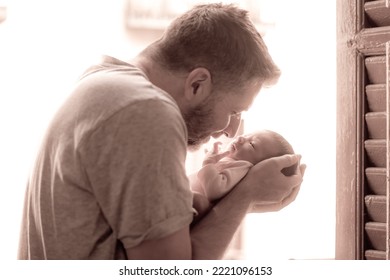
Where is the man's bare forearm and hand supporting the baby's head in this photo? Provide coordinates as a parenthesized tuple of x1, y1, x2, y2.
(191, 155, 305, 259)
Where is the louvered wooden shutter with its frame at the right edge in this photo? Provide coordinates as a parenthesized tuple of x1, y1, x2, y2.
(336, 0, 390, 260)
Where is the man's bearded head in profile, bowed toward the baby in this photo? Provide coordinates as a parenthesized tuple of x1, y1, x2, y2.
(139, 4, 280, 148)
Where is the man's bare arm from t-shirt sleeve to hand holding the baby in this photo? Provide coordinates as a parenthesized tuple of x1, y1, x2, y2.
(127, 155, 305, 259)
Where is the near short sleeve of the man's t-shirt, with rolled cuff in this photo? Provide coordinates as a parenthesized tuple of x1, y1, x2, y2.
(80, 99, 193, 248)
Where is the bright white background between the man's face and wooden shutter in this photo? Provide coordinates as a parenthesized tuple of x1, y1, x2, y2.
(242, 0, 336, 259)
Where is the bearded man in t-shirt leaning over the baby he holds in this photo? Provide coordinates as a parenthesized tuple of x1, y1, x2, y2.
(19, 4, 304, 259)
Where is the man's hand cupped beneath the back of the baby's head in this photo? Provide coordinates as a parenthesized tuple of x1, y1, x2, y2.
(237, 155, 306, 212)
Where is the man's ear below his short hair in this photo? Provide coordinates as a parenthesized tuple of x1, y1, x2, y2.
(184, 67, 212, 105)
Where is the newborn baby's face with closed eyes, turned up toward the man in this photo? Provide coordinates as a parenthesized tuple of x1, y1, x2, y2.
(229, 131, 280, 164)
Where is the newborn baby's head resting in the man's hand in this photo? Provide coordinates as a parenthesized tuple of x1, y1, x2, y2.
(228, 130, 297, 176)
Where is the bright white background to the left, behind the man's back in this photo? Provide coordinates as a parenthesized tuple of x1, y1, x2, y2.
(0, 0, 139, 260)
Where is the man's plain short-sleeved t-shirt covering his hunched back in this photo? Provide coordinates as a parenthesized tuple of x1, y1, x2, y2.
(19, 57, 193, 259)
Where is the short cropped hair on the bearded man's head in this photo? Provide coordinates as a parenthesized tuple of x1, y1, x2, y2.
(153, 4, 280, 89)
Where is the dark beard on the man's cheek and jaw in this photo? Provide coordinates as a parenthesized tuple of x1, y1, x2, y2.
(183, 100, 215, 151)
